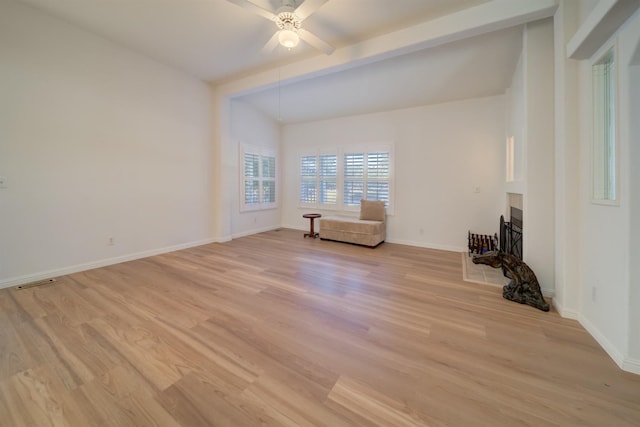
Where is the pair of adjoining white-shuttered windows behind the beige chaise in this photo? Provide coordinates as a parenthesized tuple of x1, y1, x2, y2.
(300, 147, 392, 210)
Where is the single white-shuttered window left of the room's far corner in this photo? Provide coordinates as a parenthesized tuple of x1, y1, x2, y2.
(240, 146, 277, 211)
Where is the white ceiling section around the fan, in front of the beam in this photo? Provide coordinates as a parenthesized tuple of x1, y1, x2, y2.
(21, 0, 488, 81)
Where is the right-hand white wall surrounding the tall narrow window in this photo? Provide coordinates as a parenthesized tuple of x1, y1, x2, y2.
(578, 4, 640, 373)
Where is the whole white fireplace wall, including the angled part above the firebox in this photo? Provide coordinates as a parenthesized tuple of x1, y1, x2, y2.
(502, 19, 555, 295)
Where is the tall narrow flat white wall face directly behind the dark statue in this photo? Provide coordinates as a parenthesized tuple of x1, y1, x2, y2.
(523, 19, 555, 293)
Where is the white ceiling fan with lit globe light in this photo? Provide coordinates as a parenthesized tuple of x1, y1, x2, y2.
(227, 0, 335, 55)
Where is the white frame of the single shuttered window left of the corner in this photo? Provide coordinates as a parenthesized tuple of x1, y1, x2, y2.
(239, 144, 280, 212)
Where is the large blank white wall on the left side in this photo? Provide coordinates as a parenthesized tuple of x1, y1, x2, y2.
(0, 2, 213, 286)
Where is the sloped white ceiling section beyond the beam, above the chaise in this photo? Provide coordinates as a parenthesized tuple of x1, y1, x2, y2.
(237, 26, 522, 123)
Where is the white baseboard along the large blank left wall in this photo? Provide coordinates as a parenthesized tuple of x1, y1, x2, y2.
(0, 238, 221, 289)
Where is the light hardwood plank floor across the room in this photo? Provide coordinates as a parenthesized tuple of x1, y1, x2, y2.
(0, 230, 640, 427)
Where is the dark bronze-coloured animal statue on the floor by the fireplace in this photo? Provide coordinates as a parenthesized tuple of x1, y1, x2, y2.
(473, 252, 549, 311)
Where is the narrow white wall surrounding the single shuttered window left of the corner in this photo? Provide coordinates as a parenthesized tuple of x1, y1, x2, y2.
(228, 100, 282, 238)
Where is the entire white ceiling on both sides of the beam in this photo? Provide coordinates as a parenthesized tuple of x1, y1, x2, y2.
(19, 0, 548, 123)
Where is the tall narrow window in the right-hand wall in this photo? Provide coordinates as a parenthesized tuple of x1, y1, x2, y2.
(591, 47, 617, 203)
